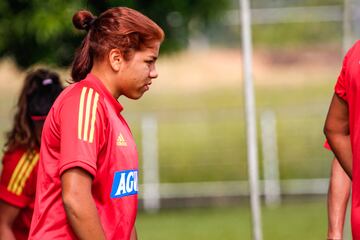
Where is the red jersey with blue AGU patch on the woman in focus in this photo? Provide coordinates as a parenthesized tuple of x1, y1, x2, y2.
(29, 74, 138, 239)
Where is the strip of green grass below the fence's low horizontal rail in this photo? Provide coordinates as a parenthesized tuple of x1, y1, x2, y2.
(137, 198, 338, 240)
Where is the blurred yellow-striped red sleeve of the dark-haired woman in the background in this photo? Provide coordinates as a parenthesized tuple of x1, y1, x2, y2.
(0, 151, 39, 208)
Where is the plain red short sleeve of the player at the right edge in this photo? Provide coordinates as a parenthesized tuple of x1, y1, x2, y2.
(335, 42, 360, 102)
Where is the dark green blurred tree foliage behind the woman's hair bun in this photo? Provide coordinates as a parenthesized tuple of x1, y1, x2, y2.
(0, 0, 231, 67)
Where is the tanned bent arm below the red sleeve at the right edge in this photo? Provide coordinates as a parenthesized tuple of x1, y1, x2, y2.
(324, 94, 352, 179)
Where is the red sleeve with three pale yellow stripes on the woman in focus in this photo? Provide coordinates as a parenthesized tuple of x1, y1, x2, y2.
(57, 87, 106, 177)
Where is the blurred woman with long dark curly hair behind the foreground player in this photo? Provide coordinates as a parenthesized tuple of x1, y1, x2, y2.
(0, 69, 62, 240)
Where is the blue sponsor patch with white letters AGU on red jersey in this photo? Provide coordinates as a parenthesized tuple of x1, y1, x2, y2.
(110, 170, 138, 198)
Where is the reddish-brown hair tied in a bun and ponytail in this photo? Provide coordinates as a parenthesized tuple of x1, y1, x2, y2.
(71, 7, 164, 82)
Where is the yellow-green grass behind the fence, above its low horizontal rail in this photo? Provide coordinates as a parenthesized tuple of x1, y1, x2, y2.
(118, 81, 332, 182)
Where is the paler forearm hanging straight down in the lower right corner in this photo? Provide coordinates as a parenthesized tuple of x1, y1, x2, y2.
(327, 158, 351, 239)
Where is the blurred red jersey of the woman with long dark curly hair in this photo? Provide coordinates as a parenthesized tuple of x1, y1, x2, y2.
(0, 148, 39, 240)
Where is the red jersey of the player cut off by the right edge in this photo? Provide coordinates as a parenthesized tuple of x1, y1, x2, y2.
(335, 41, 360, 240)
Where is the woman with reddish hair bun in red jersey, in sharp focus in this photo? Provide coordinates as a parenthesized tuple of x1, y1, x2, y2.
(29, 7, 164, 240)
